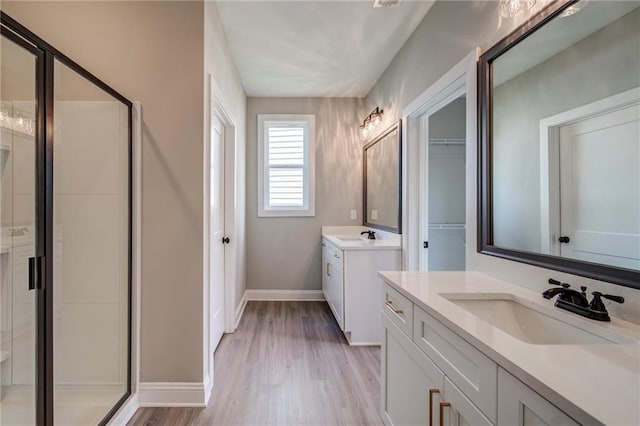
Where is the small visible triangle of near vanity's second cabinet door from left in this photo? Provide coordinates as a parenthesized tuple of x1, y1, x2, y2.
(438, 377, 495, 426)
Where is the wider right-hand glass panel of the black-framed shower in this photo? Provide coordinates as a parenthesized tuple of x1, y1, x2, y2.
(53, 59, 130, 425)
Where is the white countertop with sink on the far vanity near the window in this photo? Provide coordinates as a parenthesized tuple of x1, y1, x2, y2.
(322, 226, 402, 250)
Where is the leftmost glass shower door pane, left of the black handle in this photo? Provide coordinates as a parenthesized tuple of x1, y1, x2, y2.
(0, 28, 44, 425)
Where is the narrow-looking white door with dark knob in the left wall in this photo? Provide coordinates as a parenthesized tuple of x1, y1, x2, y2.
(209, 117, 225, 356)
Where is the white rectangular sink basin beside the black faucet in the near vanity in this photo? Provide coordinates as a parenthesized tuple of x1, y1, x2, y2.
(440, 293, 632, 345)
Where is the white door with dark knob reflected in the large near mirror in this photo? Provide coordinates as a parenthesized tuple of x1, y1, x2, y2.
(559, 104, 640, 269)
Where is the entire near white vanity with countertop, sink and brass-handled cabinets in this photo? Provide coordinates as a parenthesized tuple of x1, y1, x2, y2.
(379, 272, 640, 426)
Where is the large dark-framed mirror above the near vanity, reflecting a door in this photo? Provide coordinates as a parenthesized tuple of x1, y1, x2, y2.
(478, 0, 640, 288)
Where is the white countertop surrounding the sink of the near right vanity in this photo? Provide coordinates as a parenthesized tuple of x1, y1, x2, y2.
(379, 272, 640, 425)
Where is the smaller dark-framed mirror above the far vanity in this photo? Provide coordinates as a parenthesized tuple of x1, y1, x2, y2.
(363, 120, 402, 234)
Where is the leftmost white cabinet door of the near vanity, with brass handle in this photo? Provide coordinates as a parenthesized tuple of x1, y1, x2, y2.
(380, 314, 444, 426)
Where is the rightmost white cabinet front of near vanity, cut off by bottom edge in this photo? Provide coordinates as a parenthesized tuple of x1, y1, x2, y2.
(498, 368, 578, 426)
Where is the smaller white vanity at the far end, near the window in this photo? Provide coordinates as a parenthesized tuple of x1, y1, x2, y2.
(322, 226, 401, 345)
